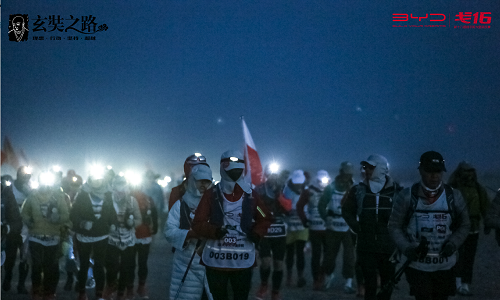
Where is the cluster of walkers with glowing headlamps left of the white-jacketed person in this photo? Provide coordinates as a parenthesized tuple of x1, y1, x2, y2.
(2, 166, 158, 300)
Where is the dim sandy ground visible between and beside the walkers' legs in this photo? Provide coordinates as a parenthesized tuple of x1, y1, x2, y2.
(1, 225, 500, 300)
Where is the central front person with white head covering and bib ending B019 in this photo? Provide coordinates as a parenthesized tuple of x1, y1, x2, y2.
(193, 150, 271, 300)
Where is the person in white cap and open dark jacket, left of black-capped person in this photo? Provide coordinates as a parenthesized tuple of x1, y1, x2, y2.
(342, 154, 402, 300)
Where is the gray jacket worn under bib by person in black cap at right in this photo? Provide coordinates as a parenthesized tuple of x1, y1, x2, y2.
(387, 182, 470, 253)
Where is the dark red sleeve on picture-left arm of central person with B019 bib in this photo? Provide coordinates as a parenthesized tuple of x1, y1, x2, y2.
(192, 189, 219, 240)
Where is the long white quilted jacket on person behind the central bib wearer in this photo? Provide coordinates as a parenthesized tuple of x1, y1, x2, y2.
(165, 201, 213, 300)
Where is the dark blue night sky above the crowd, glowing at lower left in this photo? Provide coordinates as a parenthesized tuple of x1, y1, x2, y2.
(1, 0, 500, 182)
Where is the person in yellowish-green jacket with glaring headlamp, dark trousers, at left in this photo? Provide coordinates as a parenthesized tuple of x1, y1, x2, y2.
(21, 172, 71, 299)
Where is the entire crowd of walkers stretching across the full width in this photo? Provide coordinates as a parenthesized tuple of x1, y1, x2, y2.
(1, 150, 500, 300)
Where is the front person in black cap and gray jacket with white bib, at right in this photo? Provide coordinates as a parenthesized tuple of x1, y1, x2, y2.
(387, 151, 471, 300)
